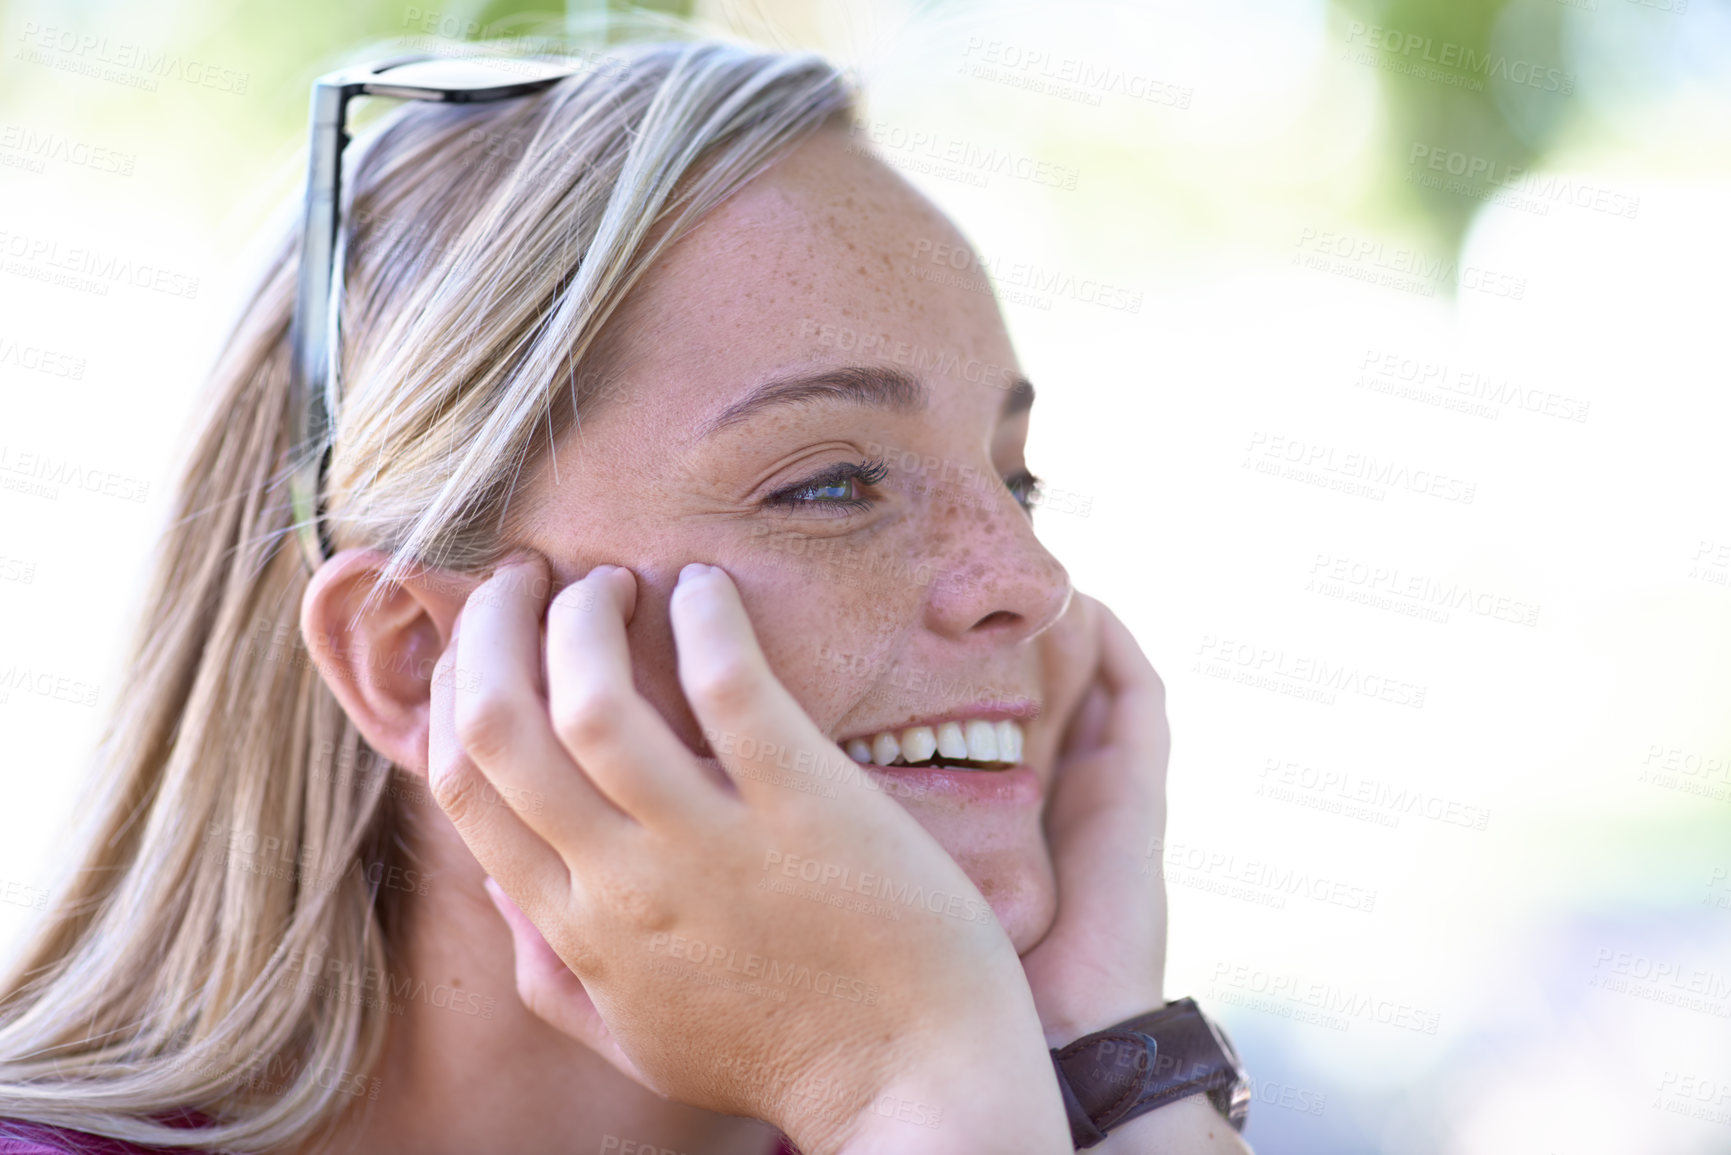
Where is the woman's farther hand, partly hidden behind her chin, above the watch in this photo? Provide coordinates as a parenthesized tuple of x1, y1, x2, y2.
(1021, 594, 1172, 1046)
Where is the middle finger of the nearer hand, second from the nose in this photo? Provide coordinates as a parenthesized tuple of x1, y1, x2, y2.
(547, 566, 722, 824)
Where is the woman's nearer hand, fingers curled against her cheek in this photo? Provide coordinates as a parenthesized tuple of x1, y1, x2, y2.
(429, 559, 1068, 1155)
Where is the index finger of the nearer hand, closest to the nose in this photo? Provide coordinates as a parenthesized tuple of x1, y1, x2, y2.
(668, 565, 874, 805)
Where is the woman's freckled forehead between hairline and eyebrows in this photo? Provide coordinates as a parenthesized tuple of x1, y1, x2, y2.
(588, 128, 1014, 433)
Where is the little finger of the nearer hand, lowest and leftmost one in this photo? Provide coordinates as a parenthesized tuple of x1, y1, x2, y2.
(428, 639, 571, 899)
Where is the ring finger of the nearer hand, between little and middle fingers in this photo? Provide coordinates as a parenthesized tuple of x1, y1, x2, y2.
(455, 558, 621, 854)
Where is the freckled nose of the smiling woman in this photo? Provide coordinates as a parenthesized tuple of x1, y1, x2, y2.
(924, 477, 1073, 644)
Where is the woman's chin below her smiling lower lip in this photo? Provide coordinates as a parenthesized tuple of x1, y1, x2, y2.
(907, 803, 1058, 954)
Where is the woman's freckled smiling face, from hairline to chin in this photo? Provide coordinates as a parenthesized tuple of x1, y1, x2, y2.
(524, 122, 1089, 951)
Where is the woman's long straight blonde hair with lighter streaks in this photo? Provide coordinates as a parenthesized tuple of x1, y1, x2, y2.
(0, 42, 852, 1152)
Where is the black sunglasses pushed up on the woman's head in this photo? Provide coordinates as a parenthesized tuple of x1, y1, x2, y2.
(289, 55, 585, 571)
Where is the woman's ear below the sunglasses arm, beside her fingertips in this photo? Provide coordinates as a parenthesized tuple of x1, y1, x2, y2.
(301, 549, 483, 774)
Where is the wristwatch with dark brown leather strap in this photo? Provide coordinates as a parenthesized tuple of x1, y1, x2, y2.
(1052, 999, 1250, 1150)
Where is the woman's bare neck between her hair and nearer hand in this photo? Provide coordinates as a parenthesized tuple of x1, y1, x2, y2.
(306, 793, 775, 1155)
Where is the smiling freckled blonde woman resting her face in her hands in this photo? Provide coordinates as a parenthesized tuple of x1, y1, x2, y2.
(0, 45, 1243, 1155)
